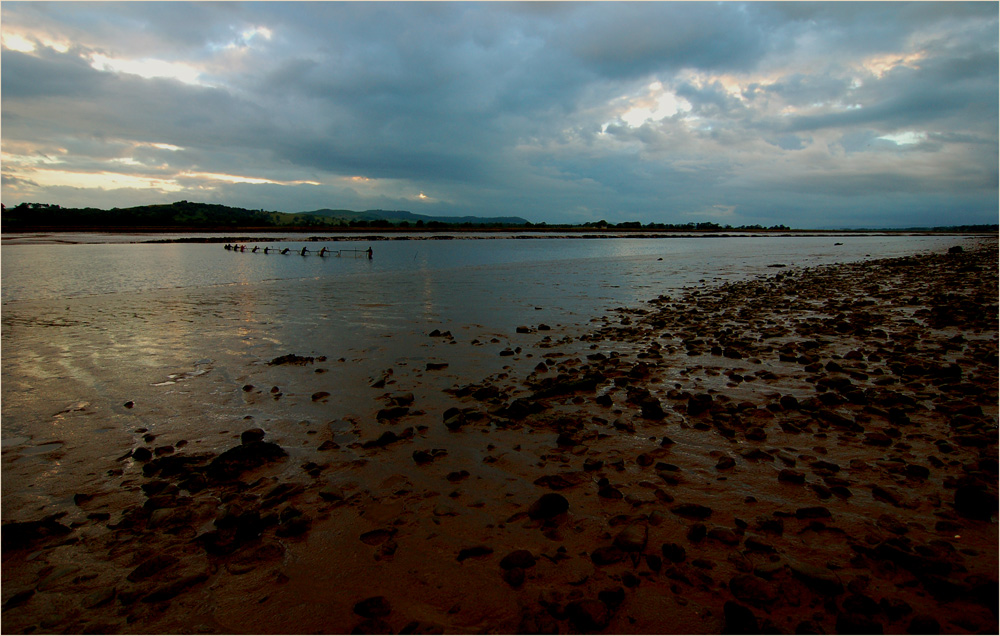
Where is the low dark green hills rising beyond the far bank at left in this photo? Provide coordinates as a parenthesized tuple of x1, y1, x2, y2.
(0, 201, 529, 231)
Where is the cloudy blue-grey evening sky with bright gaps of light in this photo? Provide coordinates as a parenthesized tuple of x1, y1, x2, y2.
(0, 1, 1000, 228)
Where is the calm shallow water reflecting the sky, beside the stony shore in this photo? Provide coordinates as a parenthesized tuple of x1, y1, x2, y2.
(2, 236, 966, 519)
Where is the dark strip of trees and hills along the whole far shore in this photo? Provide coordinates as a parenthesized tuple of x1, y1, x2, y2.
(0, 201, 998, 234)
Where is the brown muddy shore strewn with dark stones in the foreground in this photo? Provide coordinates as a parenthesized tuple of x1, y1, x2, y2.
(2, 242, 998, 634)
